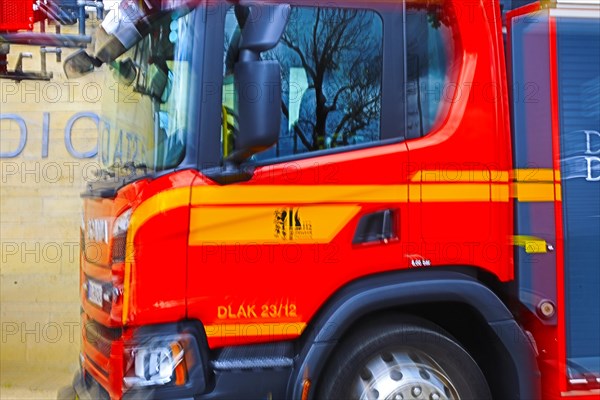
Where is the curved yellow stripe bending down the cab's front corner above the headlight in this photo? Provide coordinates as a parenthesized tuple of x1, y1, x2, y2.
(122, 188, 190, 325)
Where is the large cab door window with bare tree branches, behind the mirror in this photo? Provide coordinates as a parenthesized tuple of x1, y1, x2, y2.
(223, 7, 383, 160)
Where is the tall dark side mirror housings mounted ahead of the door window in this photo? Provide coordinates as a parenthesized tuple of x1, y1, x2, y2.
(229, 4, 291, 163)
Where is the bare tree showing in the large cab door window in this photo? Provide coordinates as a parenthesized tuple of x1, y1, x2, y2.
(270, 8, 382, 151)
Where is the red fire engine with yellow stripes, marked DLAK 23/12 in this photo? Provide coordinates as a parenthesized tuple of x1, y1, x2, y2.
(35, 0, 600, 400)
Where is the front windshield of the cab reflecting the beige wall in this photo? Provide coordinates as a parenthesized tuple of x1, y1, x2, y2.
(100, 12, 196, 171)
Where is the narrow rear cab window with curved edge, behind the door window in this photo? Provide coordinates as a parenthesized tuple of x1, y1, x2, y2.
(406, 2, 455, 138)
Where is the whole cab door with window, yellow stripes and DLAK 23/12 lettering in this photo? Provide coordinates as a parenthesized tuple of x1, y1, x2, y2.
(188, 2, 410, 347)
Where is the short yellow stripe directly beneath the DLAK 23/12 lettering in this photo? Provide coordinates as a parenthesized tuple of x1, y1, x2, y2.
(204, 322, 306, 339)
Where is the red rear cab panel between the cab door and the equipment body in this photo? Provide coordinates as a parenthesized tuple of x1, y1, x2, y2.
(408, 2, 513, 281)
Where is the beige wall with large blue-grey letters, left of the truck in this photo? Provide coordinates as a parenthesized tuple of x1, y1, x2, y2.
(0, 23, 104, 386)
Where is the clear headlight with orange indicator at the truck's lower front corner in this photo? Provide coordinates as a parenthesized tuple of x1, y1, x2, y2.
(123, 342, 186, 388)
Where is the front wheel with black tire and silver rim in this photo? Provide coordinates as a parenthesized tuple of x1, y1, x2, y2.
(317, 316, 491, 400)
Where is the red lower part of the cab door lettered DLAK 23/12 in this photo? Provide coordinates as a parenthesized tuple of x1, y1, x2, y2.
(188, 144, 411, 347)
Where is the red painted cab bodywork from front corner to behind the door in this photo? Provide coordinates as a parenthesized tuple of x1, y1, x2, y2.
(106, 2, 513, 347)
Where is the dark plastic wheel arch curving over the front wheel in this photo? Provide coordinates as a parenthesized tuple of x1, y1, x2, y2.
(288, 270, 540, 399)
